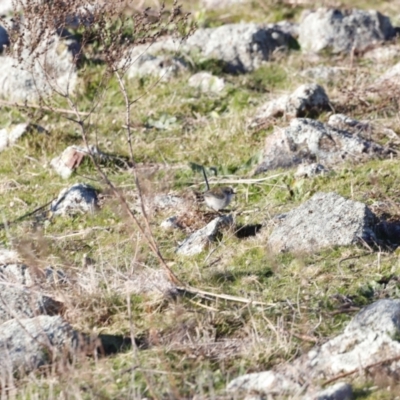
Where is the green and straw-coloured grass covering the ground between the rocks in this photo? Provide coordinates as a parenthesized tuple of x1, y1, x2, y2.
(0, 0, 400, 399)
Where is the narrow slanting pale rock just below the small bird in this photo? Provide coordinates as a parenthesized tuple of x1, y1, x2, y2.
(176, 215, 233, 256)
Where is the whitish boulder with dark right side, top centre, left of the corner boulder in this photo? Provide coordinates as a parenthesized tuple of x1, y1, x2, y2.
(184, 23, 289, 73)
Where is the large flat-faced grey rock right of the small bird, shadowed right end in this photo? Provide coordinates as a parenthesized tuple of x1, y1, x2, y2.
(268, 193, 377, 253)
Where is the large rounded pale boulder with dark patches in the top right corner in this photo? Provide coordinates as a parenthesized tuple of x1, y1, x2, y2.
(299, 8, 395, 53)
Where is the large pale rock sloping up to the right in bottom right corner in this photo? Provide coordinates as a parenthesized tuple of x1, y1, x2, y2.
(228, 299, 400, 399)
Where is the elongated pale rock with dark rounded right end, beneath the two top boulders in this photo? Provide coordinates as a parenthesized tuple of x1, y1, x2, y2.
(251, 83, 330, 126)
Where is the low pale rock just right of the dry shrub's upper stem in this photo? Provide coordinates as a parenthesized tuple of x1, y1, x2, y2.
(122, 54, 188, 82)
